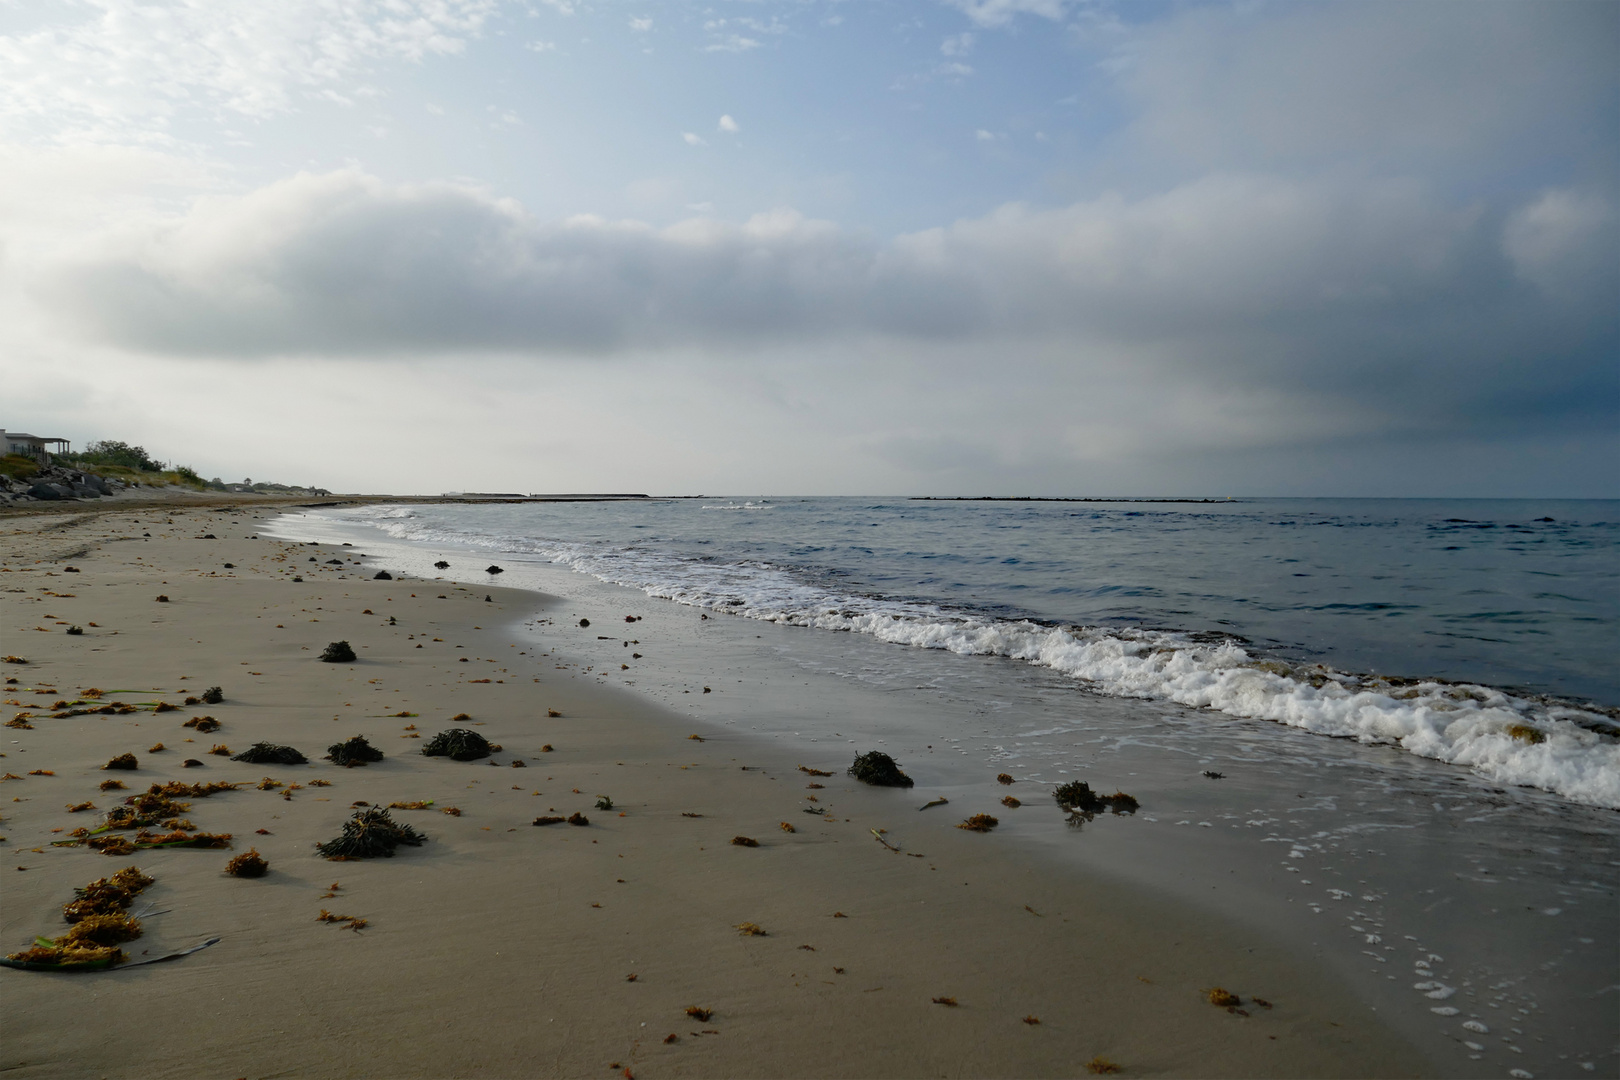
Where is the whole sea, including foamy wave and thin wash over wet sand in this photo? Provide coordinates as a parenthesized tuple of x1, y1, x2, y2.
(266, 497, 1620, 1077)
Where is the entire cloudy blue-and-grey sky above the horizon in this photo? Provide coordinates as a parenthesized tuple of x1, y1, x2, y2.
(0, 0, 1620, 497)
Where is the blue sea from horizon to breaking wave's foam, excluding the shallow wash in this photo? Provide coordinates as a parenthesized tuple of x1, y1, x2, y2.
(335, 499, 1620, 808)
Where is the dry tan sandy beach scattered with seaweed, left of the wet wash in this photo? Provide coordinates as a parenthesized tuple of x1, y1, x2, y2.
(0, 507, 1432, 1077)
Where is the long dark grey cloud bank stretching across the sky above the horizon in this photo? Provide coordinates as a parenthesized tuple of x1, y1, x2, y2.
(36, 172, 1620, 426)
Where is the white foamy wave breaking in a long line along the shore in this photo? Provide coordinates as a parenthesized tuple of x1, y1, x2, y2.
(345, 504, 1620, 810)
